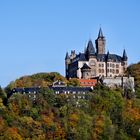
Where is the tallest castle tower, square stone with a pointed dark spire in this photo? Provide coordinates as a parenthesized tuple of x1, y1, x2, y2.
(95, 28, 106, 54)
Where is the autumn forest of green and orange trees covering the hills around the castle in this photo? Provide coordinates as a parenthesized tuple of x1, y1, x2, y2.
(0, 63, 140, 140)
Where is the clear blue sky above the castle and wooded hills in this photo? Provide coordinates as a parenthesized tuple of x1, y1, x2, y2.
(0, 0, 140, 87)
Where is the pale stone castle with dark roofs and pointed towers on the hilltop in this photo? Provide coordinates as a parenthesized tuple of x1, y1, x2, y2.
(65, 28, 128, 79)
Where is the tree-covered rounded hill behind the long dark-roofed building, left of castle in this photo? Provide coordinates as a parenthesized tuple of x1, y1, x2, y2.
(6, 72, 80, 90)
